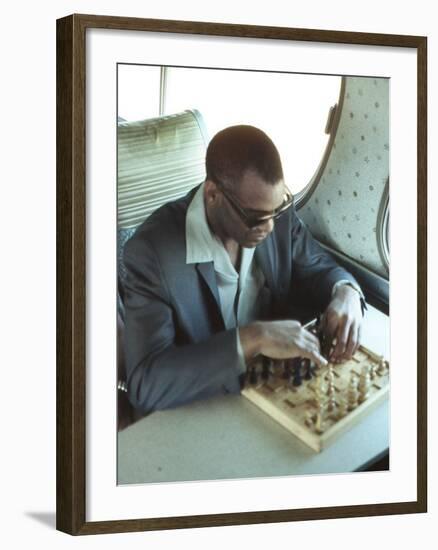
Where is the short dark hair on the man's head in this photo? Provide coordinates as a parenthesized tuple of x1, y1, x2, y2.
(205, 125, 283, 186)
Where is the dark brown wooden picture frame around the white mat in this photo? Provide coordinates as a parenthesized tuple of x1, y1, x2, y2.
(57, 15, 427, 535)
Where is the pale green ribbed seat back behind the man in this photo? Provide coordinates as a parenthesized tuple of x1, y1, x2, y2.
(117, 110, 208, 429)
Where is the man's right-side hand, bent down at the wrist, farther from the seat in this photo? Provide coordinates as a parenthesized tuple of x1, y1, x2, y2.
(321, 285, 362, 363)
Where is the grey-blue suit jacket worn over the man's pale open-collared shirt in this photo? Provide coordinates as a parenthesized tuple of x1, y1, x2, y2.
(124, 188, 357, 412)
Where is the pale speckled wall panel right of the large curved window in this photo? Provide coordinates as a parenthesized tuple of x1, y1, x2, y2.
(299, 77, 389, 278)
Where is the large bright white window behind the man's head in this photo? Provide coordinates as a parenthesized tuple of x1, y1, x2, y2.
(119, 65, 341, 194)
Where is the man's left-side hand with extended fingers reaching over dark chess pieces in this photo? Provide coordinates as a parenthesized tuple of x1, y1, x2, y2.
(239, 320, 327, 366)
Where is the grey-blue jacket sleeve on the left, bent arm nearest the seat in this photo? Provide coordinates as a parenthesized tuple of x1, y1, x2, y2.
(124, 238, 240, 412)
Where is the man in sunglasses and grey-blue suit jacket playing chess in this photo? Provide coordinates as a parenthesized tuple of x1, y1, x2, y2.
(124, 126, 362, 412)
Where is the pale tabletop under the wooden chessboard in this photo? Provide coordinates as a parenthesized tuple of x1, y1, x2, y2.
(118, 306, 389, 484)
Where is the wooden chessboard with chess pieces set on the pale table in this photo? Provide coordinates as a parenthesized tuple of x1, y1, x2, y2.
(242, 340, 389, 452)
